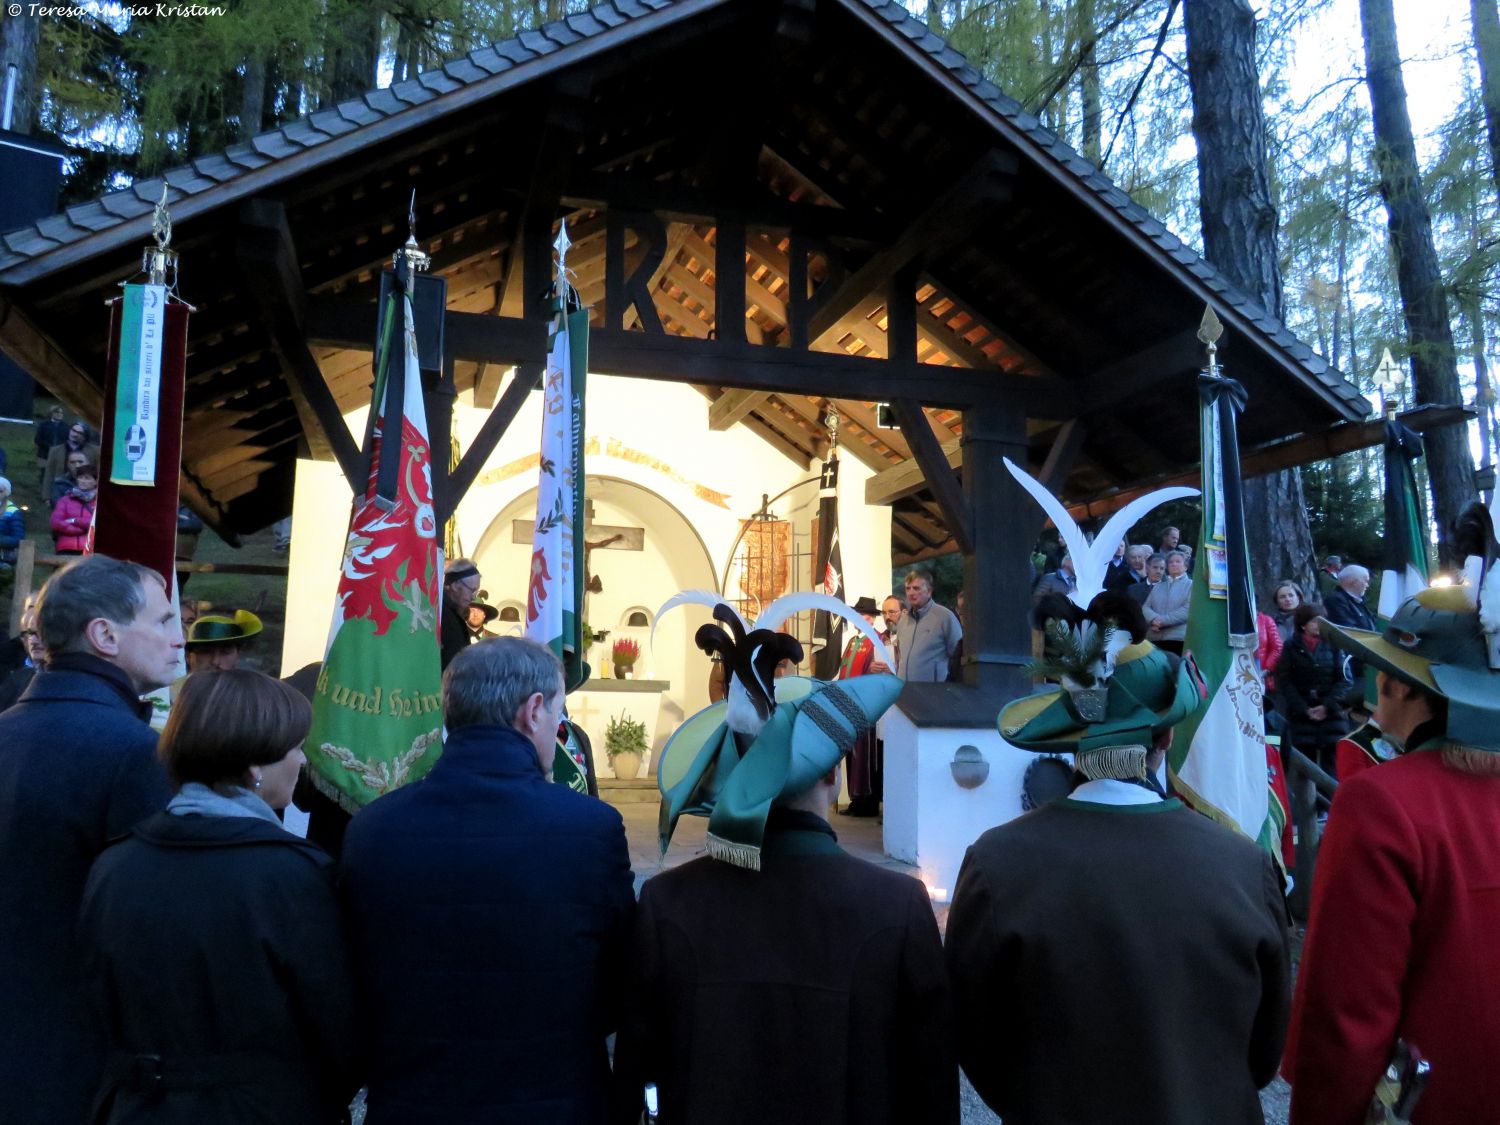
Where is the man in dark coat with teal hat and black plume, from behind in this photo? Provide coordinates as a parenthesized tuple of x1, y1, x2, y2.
(614, 618, 959, 1125)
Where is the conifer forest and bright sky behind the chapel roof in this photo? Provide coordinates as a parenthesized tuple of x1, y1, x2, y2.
(0, 0, 1500, 603)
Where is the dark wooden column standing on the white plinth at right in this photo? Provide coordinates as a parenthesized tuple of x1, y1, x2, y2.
(963, 402, 1034, 702)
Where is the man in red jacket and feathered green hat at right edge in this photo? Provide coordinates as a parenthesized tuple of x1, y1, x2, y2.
(1284, 581, 1500, 1125)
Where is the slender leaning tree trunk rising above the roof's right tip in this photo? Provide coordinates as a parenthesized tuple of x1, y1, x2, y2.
(1359, 0, 1475, 566)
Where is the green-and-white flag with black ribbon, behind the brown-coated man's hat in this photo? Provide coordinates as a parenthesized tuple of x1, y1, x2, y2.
(1167, 352, 1287, 864)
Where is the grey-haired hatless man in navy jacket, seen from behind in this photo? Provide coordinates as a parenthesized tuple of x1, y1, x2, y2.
(342, 638, 635, 1125)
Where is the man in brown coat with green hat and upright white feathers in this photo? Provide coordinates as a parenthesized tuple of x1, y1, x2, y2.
(947, 594, 1290, 1125)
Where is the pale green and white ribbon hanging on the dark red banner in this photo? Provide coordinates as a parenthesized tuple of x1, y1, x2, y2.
(110, 285, 165, 485)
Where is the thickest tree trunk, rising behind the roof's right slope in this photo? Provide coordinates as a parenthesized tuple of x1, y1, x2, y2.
(1184, 0, 1313, 600)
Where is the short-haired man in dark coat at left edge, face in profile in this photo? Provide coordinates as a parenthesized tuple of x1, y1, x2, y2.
(0, 555, 183, 1125)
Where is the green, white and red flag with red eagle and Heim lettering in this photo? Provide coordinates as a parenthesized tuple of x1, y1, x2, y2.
(305, 266, 443, 812)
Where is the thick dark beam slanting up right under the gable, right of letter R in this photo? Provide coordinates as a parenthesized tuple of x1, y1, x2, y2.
(807, 152, 1017, 344)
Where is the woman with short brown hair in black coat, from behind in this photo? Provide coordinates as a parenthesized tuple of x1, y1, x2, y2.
(80, 669, 357, 1125)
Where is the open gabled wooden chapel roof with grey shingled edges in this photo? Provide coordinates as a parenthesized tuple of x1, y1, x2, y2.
(0, 0, 1367, 560)
